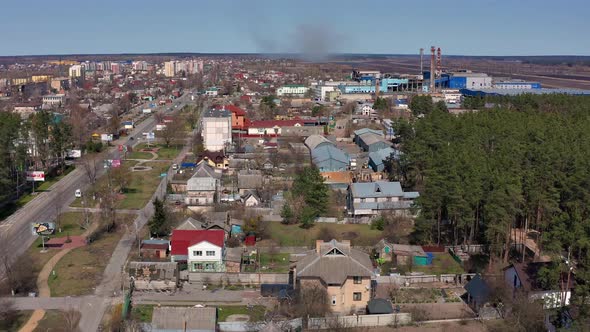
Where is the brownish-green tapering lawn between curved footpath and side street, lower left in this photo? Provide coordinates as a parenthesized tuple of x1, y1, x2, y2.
(48, 215, 135, 297)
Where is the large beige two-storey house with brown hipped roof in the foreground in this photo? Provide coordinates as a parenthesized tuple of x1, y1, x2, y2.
(295, 240, 374, 313)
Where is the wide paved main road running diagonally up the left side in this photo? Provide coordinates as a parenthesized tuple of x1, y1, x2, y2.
(0, 93, 190, 277)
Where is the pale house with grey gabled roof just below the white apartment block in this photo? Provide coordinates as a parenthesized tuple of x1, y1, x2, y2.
(185, 162, 221, 206)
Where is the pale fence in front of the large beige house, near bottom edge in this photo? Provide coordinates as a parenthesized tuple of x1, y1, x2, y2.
(307, 313, 412, 330)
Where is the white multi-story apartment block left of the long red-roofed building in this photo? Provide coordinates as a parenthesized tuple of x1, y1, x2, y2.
(201, 109, 232, 151)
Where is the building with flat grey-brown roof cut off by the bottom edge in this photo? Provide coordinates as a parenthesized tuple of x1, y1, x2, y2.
(149, 306, 217, 332)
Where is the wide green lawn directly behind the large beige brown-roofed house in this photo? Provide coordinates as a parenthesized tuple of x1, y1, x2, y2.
(269, 222, 382, 247)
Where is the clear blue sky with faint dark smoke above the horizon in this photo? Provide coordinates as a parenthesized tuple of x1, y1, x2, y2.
(0, 0, 590, 55)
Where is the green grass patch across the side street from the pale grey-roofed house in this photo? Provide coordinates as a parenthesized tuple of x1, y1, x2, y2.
(117, 162, 170, 209)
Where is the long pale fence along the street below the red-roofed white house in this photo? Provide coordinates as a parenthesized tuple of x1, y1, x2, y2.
(188, 272, 289, 285)
